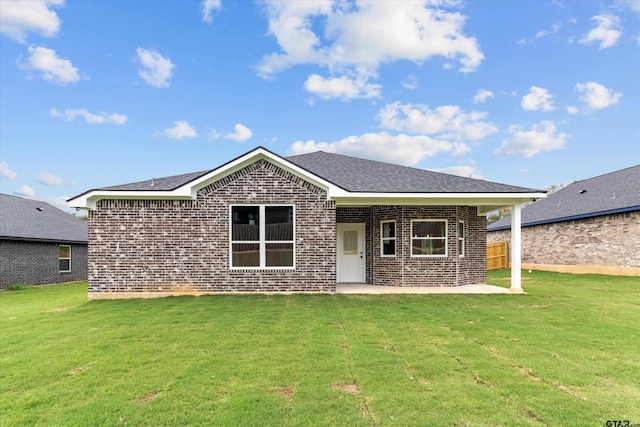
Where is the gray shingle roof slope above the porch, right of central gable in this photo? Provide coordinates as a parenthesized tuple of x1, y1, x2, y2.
(287, 151, 539, 193)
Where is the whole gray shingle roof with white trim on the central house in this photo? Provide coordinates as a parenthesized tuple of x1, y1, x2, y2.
(69, 147, 545, 212)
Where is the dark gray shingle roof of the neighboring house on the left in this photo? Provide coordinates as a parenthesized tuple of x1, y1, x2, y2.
(0, 194, 87, 244)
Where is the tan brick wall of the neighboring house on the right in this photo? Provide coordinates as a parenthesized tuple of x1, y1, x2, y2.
(487, 211, 640, 267)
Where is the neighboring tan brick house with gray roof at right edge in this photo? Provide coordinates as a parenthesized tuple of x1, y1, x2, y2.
(487, 165, 640, 276)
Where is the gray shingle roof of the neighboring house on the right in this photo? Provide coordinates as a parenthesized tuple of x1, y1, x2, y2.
(487, 165, 640, 231)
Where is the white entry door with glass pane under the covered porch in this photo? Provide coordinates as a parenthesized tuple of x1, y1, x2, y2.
(337, 223, 365, 283)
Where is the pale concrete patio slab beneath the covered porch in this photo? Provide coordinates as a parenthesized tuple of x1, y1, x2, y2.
(336, 283, 524, 294)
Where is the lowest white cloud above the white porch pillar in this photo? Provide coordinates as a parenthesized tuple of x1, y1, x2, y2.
(494, 121, 571, 157)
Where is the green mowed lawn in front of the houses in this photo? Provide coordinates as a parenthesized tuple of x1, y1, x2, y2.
(0, 271, 640, 426)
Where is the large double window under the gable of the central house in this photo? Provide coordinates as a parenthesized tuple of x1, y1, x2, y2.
(231, 205, 294, 268)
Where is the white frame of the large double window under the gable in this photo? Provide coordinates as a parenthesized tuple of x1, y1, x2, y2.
(228, 203, 296, 270)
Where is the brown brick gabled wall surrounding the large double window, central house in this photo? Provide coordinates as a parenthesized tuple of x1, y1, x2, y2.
(89, 160, 336, 298)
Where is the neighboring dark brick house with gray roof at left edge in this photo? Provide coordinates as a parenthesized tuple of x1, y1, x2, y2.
(0, 194, 87, 288)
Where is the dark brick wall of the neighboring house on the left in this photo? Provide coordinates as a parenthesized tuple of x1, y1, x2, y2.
(0, 240, 87, 288)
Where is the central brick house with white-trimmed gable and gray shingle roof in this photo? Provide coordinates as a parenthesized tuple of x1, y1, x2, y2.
(69, 147, 544, 299)
